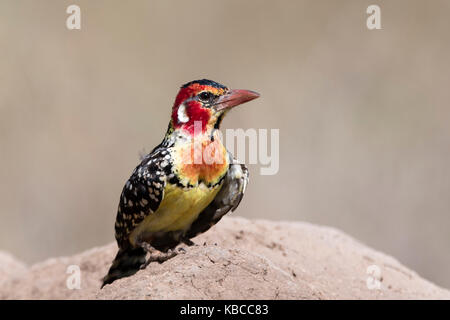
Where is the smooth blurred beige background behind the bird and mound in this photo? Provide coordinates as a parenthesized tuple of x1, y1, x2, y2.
(0, 0, 450, 287)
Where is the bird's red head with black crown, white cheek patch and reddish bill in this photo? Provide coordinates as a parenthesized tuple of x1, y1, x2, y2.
(171, 79, 259, 135)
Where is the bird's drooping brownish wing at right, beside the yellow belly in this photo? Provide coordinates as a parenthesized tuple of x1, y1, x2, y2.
(185, 155, 249, 239)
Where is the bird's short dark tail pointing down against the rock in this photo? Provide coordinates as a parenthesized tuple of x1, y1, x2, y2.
(102, 248, 146, 288)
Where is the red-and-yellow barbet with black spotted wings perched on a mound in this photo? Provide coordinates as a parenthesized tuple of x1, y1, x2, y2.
(101, 79, 260, 288)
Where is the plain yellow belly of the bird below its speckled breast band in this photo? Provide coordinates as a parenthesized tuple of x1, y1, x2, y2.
(130, 183, 221, 244)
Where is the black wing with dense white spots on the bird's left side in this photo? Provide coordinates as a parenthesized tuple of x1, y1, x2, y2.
(115, 147, 170, 248)
